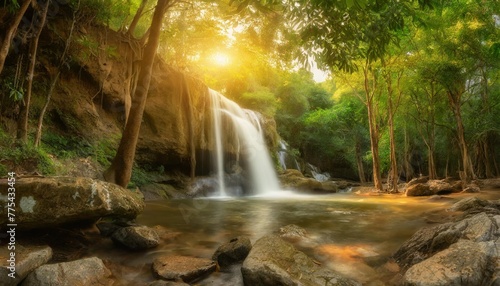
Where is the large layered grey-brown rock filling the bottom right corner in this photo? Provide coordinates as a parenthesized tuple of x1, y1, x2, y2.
(393, 198, 500, 285)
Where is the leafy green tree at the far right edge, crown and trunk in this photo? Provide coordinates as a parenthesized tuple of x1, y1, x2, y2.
(417, 1, 500, 182)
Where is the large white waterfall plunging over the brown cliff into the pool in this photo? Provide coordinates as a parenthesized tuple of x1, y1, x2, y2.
(209, 90, 280, 196)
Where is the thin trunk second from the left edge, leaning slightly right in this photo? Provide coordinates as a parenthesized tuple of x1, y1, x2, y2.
(17, 0, 50, 142)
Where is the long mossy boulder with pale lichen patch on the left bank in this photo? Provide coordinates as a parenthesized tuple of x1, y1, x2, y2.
(0, 177, 144, 229)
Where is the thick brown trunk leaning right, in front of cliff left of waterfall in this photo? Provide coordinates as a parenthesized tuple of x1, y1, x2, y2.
(104, 0, 170, 187)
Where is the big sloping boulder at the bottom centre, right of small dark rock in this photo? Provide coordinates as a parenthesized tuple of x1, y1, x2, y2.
(241, 235, 361, 286)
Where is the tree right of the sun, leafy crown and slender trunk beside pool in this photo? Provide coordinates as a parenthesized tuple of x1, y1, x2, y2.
(290, 0, 422, 190)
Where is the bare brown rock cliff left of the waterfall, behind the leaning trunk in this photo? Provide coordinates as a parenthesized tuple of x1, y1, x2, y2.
(6, 17, 277, 178)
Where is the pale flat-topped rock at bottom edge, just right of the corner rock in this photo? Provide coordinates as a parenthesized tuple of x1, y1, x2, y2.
(22, 257, 113, 286)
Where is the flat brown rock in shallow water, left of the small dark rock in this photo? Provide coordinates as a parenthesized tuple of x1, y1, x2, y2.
(153, 255, 216, 283)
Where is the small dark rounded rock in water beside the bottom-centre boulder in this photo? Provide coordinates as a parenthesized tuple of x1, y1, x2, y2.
(212, 236, 252, 267)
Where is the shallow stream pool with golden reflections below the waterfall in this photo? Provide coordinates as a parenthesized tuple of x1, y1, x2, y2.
(88, 191, 498, 286)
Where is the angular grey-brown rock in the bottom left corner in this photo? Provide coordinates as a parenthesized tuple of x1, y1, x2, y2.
(0, 244, 52, 286)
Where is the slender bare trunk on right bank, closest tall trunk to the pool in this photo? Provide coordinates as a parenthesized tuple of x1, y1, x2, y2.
(363, 62, 384, 191)
